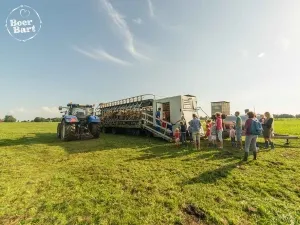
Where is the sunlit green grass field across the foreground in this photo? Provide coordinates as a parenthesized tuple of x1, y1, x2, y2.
(0, 120, 300, 225)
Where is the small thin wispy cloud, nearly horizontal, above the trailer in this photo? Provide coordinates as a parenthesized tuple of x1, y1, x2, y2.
(73, 46, 131, 66)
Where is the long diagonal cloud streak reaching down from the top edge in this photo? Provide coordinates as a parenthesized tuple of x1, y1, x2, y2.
(101, 0, 149, 60)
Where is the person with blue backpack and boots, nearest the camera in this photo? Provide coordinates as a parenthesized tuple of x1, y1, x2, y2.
(243, 112, 258, 161)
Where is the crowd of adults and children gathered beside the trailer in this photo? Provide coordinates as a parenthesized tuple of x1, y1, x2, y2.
(157, 108, 275, 161)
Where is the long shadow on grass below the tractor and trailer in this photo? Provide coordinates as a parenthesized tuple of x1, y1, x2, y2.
(0, 133, 165, 154)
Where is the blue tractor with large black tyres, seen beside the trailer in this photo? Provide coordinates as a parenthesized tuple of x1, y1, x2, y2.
(57, 103, 100, 141)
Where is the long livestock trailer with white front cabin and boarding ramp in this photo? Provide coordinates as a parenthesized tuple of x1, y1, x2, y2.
(96, 94, 204, 142)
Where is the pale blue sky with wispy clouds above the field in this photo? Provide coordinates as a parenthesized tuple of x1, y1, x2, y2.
(0, 0, 300, 120)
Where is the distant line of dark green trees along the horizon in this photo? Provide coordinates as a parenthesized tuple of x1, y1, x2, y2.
(0, 114, 300, 123)
